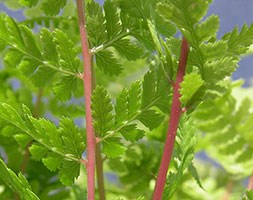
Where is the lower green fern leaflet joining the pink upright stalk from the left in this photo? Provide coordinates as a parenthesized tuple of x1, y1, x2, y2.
(0, 103, 85, 185)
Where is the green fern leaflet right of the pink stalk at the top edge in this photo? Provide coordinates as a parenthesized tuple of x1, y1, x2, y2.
(86, 0, 143, 76)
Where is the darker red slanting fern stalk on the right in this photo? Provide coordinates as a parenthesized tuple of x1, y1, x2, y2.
(153, 38, 189, 200)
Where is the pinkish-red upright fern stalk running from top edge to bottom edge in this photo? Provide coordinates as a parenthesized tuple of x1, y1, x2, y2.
(76, 0, 96, 200)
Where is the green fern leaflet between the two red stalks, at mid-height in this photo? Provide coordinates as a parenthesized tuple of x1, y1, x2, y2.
(92, 71, 168, 157)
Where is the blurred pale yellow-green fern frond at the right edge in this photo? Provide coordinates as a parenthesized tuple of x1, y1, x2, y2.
(194, 83, 253, 177)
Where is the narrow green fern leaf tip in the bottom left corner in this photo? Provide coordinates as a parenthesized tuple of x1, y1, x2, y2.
(0, 159, 39, 200)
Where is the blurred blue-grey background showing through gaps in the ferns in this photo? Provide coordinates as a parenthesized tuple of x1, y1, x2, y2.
(0, 0, 253, 85)
